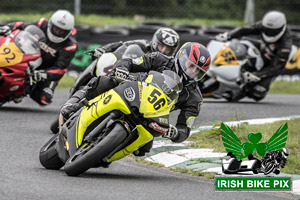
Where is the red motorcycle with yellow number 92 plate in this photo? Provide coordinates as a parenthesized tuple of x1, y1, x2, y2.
(0, 25, 45, 106)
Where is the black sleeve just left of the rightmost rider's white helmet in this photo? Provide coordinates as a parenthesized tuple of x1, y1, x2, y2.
(228, 22, 261, 38)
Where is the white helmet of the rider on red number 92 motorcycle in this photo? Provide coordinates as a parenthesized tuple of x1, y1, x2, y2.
(47, 10, 75, 43)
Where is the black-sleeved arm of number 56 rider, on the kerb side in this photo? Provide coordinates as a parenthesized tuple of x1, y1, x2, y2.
(172, 83, 203, 143)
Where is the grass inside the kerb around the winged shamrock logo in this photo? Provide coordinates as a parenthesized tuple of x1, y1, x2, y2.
(189, 119, 300, 175)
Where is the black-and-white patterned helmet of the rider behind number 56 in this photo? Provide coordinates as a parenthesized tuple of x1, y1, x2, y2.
(151, 28, 179, 56)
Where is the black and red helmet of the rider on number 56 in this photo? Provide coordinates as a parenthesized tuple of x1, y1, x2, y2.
(175, 42, 211, 81)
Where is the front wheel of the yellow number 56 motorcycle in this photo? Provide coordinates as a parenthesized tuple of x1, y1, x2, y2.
(64, 123, 127, 176)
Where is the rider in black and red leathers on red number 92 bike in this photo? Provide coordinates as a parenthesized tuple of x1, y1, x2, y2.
(0, 10, 77, 106)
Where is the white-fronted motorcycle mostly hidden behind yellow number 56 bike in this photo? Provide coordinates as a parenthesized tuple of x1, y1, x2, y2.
(50, 44, 144, 133)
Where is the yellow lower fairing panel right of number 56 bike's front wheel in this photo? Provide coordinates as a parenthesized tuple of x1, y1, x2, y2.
(107, 125, 153, 162)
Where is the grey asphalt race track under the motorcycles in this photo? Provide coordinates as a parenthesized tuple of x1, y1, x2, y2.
(0, 90, 300, 200)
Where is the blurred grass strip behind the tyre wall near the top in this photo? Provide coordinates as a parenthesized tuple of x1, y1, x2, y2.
(0, 12, 244, 26)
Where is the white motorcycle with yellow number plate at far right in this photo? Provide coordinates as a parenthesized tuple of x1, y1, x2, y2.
(199, 37, 297, 101)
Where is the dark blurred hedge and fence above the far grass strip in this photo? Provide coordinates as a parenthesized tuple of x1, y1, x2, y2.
(0, 0, 300, 24)
